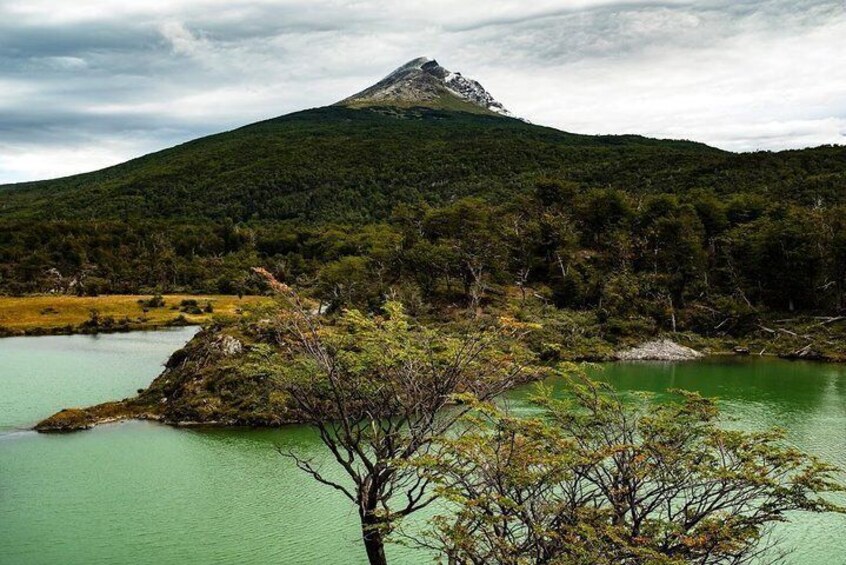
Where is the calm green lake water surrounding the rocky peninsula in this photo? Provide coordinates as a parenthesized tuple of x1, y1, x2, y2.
(0, 329, 846, 565)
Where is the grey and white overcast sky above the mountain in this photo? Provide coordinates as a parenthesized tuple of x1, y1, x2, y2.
(0, 0, 846, 183)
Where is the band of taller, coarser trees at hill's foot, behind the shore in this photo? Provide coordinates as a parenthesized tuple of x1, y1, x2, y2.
(0, 184, 846, 326)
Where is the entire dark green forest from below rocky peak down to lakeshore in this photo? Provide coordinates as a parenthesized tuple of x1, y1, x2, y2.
(0, 107, 846, 344)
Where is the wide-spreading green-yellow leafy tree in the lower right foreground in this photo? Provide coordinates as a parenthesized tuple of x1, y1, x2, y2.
(420, 370, 844, 565)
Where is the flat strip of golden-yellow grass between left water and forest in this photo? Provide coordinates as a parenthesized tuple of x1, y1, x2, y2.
(0, 294, 267, 333)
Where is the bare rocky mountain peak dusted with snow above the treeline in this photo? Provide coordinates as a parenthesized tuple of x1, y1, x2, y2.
(338, 57, 511, 116)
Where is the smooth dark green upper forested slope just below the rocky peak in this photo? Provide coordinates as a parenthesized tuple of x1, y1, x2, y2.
(0, 106, 846, 223)
